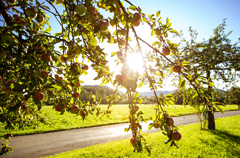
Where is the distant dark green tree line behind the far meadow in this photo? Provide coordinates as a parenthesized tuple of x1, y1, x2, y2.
(54, 85, 240, 105)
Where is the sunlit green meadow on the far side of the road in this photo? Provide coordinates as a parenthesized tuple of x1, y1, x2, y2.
(0, 104, 238, 136)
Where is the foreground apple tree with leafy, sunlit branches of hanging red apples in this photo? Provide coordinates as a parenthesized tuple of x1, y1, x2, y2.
(0, 0, 217, 154)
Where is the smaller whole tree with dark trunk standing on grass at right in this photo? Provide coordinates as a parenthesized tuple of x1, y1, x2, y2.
(182, 20, 240, 129)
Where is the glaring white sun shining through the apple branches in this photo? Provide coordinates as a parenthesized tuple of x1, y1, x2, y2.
(127, 53, 144, 73)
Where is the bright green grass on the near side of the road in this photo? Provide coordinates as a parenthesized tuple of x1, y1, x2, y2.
(44, 116, 240, 158)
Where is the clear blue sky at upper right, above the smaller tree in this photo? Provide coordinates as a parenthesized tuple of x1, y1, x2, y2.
(132, 0, 240, 42)
